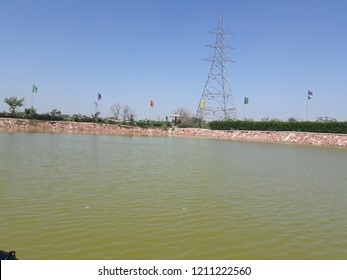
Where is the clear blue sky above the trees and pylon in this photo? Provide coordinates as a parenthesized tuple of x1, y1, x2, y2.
(0, 0, 347, 121)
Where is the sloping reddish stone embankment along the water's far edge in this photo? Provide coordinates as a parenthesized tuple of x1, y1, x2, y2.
(0, 118, 347, 148)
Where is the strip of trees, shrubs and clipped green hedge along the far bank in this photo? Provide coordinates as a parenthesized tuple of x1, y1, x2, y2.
(0, 96, 347, 134)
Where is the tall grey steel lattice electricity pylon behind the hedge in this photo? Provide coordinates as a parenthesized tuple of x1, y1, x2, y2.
(196, 13, 237, 121)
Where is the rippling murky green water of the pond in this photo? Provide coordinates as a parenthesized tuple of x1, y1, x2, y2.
(0, 132, 347, 259)
